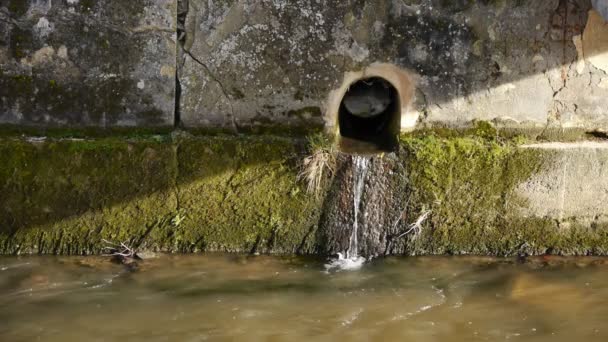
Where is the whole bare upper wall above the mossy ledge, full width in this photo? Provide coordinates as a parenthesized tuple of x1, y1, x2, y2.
(0, 0, 608, 131)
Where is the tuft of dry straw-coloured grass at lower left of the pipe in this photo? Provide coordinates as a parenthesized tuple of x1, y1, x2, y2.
(298, 134, 336, 197)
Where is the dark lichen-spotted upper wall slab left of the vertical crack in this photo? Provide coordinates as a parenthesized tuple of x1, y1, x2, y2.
(0, 0, 176, 127)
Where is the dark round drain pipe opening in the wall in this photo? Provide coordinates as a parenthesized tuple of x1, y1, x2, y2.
(338, 77, 401, 153)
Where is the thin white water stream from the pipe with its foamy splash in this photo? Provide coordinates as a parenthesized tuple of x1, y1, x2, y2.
(325, 156, 369, 272)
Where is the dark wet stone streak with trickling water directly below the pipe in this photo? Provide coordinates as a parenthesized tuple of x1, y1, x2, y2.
(319, 154, 406, 271)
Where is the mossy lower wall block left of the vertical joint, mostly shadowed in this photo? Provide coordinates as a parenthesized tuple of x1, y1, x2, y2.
(0, 139, 176, 254)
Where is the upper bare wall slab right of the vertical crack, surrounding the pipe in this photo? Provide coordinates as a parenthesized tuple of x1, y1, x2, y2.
(178, 0, 608, 131)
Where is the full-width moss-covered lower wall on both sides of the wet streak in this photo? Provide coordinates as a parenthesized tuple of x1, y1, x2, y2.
(0, 130, 608, 255)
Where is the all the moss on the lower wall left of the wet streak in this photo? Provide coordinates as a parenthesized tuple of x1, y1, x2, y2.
(0, 137, 324, 254)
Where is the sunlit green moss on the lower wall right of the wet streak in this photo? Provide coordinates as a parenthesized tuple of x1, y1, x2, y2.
(394, 131, 608, 255)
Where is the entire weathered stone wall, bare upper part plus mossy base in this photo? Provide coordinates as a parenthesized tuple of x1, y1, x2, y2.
(0, 0, 608, 255)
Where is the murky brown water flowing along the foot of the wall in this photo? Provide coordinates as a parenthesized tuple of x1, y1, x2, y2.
(0, 255, 608, 341)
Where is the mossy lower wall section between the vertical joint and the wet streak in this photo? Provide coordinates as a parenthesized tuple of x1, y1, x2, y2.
(171, 137, 319, 253)
